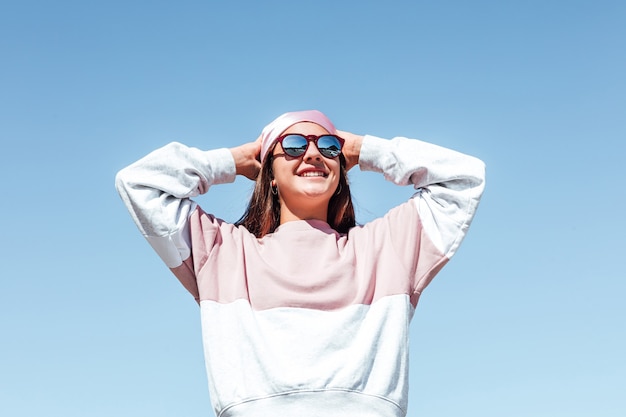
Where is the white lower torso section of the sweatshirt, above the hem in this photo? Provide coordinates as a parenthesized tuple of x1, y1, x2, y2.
(200, 295, 413, 415)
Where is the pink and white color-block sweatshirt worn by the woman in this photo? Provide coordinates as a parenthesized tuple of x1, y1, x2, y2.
(116, 136, 484, 417)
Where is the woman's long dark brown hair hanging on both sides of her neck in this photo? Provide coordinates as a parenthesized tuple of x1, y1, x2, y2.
(235, 152, 356, 238)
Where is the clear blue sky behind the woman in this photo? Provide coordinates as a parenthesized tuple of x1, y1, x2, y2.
(0, 0, 626, 417)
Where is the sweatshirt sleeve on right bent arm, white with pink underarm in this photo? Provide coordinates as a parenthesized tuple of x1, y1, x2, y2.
(359, 136, 485, 294)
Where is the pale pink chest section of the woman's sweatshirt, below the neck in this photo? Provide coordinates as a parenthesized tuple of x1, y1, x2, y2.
(185, 201, 447, 310)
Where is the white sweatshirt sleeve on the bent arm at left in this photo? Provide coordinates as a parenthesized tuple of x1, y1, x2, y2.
(115, 142, 236, 293)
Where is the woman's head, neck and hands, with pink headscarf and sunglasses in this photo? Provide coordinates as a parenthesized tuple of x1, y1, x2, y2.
(232, 111, 356, 238)
